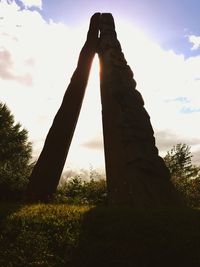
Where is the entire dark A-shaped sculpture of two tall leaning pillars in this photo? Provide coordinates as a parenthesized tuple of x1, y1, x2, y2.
(27, 13, 180, 207)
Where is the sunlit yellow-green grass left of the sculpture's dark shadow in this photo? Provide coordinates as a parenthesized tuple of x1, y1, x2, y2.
(0, 205, 88, 267)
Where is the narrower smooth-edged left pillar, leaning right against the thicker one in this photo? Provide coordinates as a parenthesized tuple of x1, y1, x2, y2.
(26, 13, 100, 201)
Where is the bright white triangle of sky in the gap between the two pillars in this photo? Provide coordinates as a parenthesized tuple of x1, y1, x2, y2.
(65, 55, 105, 169)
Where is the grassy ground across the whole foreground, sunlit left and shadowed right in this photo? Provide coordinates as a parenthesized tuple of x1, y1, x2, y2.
(0, 204, 200, 267)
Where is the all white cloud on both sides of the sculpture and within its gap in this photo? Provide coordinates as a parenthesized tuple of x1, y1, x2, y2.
(0, 0, 200, 170)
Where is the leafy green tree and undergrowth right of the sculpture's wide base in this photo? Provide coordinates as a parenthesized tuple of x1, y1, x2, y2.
(164, 144, 200, 207)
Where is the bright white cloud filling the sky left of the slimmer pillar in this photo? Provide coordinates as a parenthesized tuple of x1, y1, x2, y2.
(0, 1, 91, 168)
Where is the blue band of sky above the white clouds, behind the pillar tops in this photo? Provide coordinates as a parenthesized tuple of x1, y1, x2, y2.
(16, 0, 200, 57)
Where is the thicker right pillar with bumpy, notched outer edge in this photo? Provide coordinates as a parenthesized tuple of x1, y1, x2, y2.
(98, 13, 180, 207)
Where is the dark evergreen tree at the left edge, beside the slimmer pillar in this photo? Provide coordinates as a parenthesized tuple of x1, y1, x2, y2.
(0, 102, 33, 200)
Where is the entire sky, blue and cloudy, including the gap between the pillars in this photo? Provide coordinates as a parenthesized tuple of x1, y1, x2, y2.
(0, 0, 200, 174)
